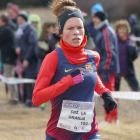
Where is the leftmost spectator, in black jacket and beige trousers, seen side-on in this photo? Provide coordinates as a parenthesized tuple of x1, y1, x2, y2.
(0, 14, 18, 104)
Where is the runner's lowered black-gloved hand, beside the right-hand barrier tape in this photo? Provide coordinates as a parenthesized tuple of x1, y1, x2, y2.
(102, 92, 117, 114)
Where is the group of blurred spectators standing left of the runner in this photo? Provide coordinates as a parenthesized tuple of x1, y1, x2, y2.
(0, 3, 60, 107)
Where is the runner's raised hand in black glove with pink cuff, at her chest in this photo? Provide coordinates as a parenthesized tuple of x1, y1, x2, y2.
(70, 67, 85, 84)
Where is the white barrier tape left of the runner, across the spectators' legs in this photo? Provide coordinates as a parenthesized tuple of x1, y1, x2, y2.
(0, 75, 35, 85)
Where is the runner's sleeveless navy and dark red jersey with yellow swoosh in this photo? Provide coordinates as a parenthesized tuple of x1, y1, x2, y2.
(46, 48, 98, 140)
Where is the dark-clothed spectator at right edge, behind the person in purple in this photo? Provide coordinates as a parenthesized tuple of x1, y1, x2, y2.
(129, 14, 140, 47)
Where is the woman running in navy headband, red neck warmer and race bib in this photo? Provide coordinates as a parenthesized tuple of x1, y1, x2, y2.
(32, 0, 117, 140)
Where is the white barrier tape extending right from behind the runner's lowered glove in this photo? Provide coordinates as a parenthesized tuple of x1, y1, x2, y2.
(96, 91, 140, 100)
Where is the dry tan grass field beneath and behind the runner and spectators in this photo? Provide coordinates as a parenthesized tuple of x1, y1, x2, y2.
(0, 8, 140, 140)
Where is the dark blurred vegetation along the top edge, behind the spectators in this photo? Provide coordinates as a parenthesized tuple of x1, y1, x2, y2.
(0, 0, 140, 21)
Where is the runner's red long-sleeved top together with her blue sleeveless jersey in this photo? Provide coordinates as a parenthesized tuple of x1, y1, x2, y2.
(32, 39, 110, 140)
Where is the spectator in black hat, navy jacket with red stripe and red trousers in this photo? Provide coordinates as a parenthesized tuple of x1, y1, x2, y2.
(93, 12, 119, 123)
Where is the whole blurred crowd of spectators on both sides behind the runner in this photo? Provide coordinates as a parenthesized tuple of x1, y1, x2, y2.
(0, 3, 140, 122)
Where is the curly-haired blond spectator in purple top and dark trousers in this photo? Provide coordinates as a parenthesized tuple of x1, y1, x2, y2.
(115, 20, 140, 91)
